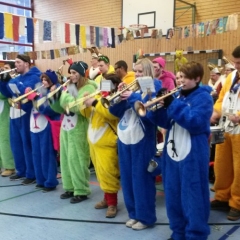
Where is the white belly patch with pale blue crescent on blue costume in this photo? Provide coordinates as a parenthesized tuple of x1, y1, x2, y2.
(118, 109, 145, 145)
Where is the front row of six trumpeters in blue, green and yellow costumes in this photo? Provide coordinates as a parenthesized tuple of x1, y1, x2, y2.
(0, 52, 221, 240)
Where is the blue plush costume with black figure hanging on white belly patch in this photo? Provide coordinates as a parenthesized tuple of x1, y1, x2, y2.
(148, 86, 213, 240)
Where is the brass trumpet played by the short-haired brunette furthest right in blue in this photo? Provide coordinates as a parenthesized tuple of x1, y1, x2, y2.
(134, 85, 182, 117)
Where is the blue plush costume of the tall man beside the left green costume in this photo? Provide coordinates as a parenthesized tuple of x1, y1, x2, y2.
(1, 55, 41, 180)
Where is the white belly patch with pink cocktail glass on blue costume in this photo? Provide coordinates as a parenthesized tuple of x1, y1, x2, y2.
(30, 108, 48, 133)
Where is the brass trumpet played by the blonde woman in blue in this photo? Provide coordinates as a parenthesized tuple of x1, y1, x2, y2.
(101, 79, 140, 108)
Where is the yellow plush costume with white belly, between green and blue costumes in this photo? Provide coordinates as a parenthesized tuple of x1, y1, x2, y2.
(81, 98, 120, 210)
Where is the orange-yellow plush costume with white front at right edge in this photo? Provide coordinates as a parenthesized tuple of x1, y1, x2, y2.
(214, 70, 240, 210)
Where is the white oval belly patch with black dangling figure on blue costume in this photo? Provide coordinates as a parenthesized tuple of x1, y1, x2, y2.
(167, 123, 192, 162)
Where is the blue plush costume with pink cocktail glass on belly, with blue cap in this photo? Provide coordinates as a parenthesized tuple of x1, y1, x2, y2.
(30, 70, 61, 192)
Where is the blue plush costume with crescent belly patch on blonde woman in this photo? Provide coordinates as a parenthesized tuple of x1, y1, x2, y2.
(110, 79, 161, 226)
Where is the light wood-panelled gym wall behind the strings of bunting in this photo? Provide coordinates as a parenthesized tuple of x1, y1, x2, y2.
(35, 0, 240, 83)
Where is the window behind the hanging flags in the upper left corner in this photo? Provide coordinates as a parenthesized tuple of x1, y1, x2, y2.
(0, 0, 33, 60)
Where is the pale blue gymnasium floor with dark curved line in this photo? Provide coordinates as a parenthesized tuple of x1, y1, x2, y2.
(0, 174, 240, 240)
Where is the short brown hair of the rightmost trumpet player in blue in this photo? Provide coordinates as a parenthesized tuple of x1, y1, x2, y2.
(179, 61, 204, 81)
